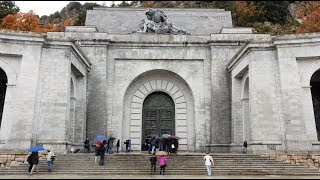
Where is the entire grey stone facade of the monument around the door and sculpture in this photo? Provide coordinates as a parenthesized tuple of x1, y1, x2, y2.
(0, 8, 320, 153)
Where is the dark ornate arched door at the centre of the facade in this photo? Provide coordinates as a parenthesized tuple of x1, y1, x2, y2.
(141, 91, 175, 149)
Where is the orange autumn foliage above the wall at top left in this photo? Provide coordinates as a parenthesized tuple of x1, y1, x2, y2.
(0, 11, 58, 33)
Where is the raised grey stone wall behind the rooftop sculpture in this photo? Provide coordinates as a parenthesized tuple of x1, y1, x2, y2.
(86, 7, 232, 35)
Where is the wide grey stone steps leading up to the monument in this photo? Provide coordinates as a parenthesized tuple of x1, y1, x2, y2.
(0, 152, 320, 176)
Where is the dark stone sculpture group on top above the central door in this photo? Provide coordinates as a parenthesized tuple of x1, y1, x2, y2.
(136, 8, 189, 35)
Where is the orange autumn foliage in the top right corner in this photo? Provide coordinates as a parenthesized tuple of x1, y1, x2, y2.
(297, 1, 320, 33)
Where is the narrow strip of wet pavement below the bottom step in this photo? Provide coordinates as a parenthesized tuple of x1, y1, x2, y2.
(0, 174, 320, 179)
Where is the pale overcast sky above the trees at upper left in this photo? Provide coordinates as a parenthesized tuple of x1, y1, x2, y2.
(14, 1, 121, 17)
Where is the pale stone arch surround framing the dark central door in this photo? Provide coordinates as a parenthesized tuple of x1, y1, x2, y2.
(122, 69, 195, 150)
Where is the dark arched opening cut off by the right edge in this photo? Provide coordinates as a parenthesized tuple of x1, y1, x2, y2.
(310, 70, 320, 141)
